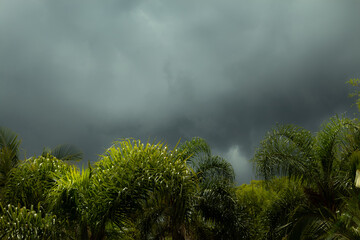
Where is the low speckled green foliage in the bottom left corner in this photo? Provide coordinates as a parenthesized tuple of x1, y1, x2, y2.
(0, 204, 66, 240)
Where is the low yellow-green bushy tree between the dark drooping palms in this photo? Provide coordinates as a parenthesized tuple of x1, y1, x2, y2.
(236, 177, 304, 240)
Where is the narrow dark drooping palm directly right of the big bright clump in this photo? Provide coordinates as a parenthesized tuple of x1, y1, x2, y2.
(179, 137, 247, 239)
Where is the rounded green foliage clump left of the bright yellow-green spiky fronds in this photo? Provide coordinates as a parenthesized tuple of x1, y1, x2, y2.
(5, 156, 72, 210)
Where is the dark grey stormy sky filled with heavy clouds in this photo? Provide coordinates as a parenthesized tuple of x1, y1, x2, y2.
(0, 0, 360, 183)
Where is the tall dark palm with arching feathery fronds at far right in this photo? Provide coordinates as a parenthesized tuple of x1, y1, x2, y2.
(253, 117, 360, 237)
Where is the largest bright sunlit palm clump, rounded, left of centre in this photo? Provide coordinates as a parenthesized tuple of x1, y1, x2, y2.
(48, 140, 196, 239)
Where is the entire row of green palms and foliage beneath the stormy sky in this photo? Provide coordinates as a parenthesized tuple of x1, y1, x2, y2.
(0, 117, 360, 240)
